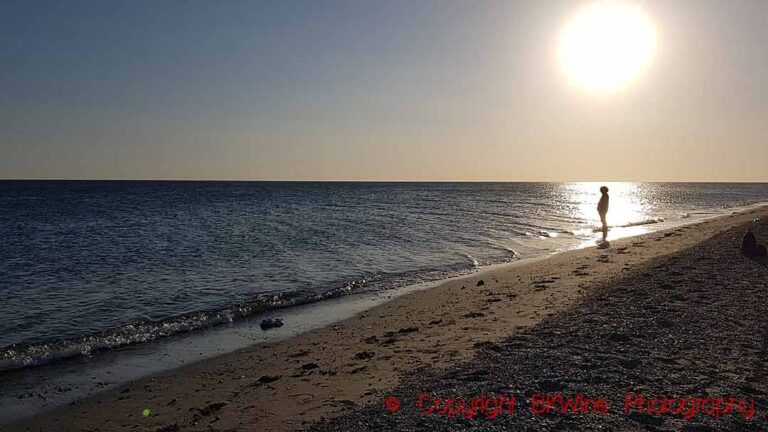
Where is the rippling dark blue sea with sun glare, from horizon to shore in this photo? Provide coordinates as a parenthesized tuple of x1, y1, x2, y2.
(0, 181, 768, 371)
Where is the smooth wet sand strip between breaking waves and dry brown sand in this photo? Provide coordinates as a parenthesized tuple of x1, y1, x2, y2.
(0, 202, 768, 426)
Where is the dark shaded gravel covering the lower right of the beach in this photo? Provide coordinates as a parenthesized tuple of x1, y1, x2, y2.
(310, 224, 768, 432)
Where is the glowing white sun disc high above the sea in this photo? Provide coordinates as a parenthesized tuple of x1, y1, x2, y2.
(558, 1, 656, 92)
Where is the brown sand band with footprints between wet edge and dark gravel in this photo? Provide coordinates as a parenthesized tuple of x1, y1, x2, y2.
(9, 206, 766, 430)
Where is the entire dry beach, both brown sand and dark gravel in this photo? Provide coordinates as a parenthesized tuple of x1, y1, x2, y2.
(3, 207, 768, 431)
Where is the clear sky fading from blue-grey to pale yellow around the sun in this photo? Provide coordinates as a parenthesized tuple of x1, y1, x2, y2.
(0, 0, 768, 181)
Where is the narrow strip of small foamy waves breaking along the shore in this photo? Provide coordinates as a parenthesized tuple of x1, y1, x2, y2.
(0, 203, 765, 375)
